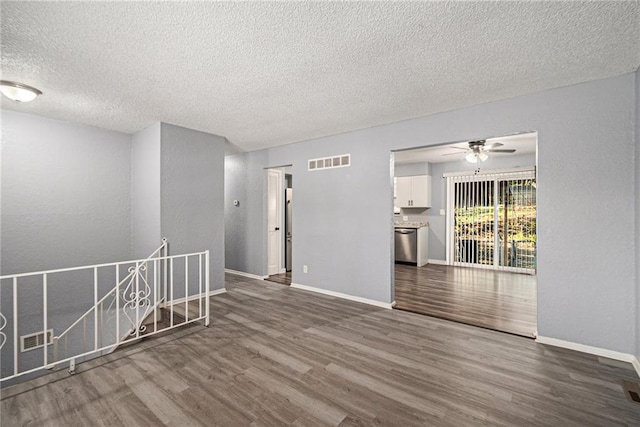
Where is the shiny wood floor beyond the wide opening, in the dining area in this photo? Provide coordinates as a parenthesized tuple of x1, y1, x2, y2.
(395, 264, 536, 338)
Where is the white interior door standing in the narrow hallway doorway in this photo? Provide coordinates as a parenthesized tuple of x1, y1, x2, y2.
(267, 169, 283, 276)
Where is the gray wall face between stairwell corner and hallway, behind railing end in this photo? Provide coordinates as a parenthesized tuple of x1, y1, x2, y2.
(160, 123, 226, 290)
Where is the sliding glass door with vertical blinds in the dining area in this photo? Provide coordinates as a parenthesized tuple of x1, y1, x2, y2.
(446, 169, 536, 273)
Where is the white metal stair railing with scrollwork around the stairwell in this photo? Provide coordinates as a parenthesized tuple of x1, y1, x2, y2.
(0, 239, 210, 382)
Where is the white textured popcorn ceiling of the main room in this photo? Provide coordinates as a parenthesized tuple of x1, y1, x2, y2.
(0, 1, 640, 150)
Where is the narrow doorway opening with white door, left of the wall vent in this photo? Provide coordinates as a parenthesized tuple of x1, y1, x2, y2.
(267, 166, 293, 285)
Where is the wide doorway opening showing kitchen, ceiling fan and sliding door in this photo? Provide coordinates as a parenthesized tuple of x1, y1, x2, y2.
(393, 132, 537, 337)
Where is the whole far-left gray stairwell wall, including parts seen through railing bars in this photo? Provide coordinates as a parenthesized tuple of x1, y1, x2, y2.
(0, 110, 131, 386)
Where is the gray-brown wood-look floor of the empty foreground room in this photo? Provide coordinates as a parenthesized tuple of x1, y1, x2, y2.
(0, 275, 640, 427)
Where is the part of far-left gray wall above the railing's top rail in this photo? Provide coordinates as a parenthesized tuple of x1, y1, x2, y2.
(0, 110, 131, 274)
